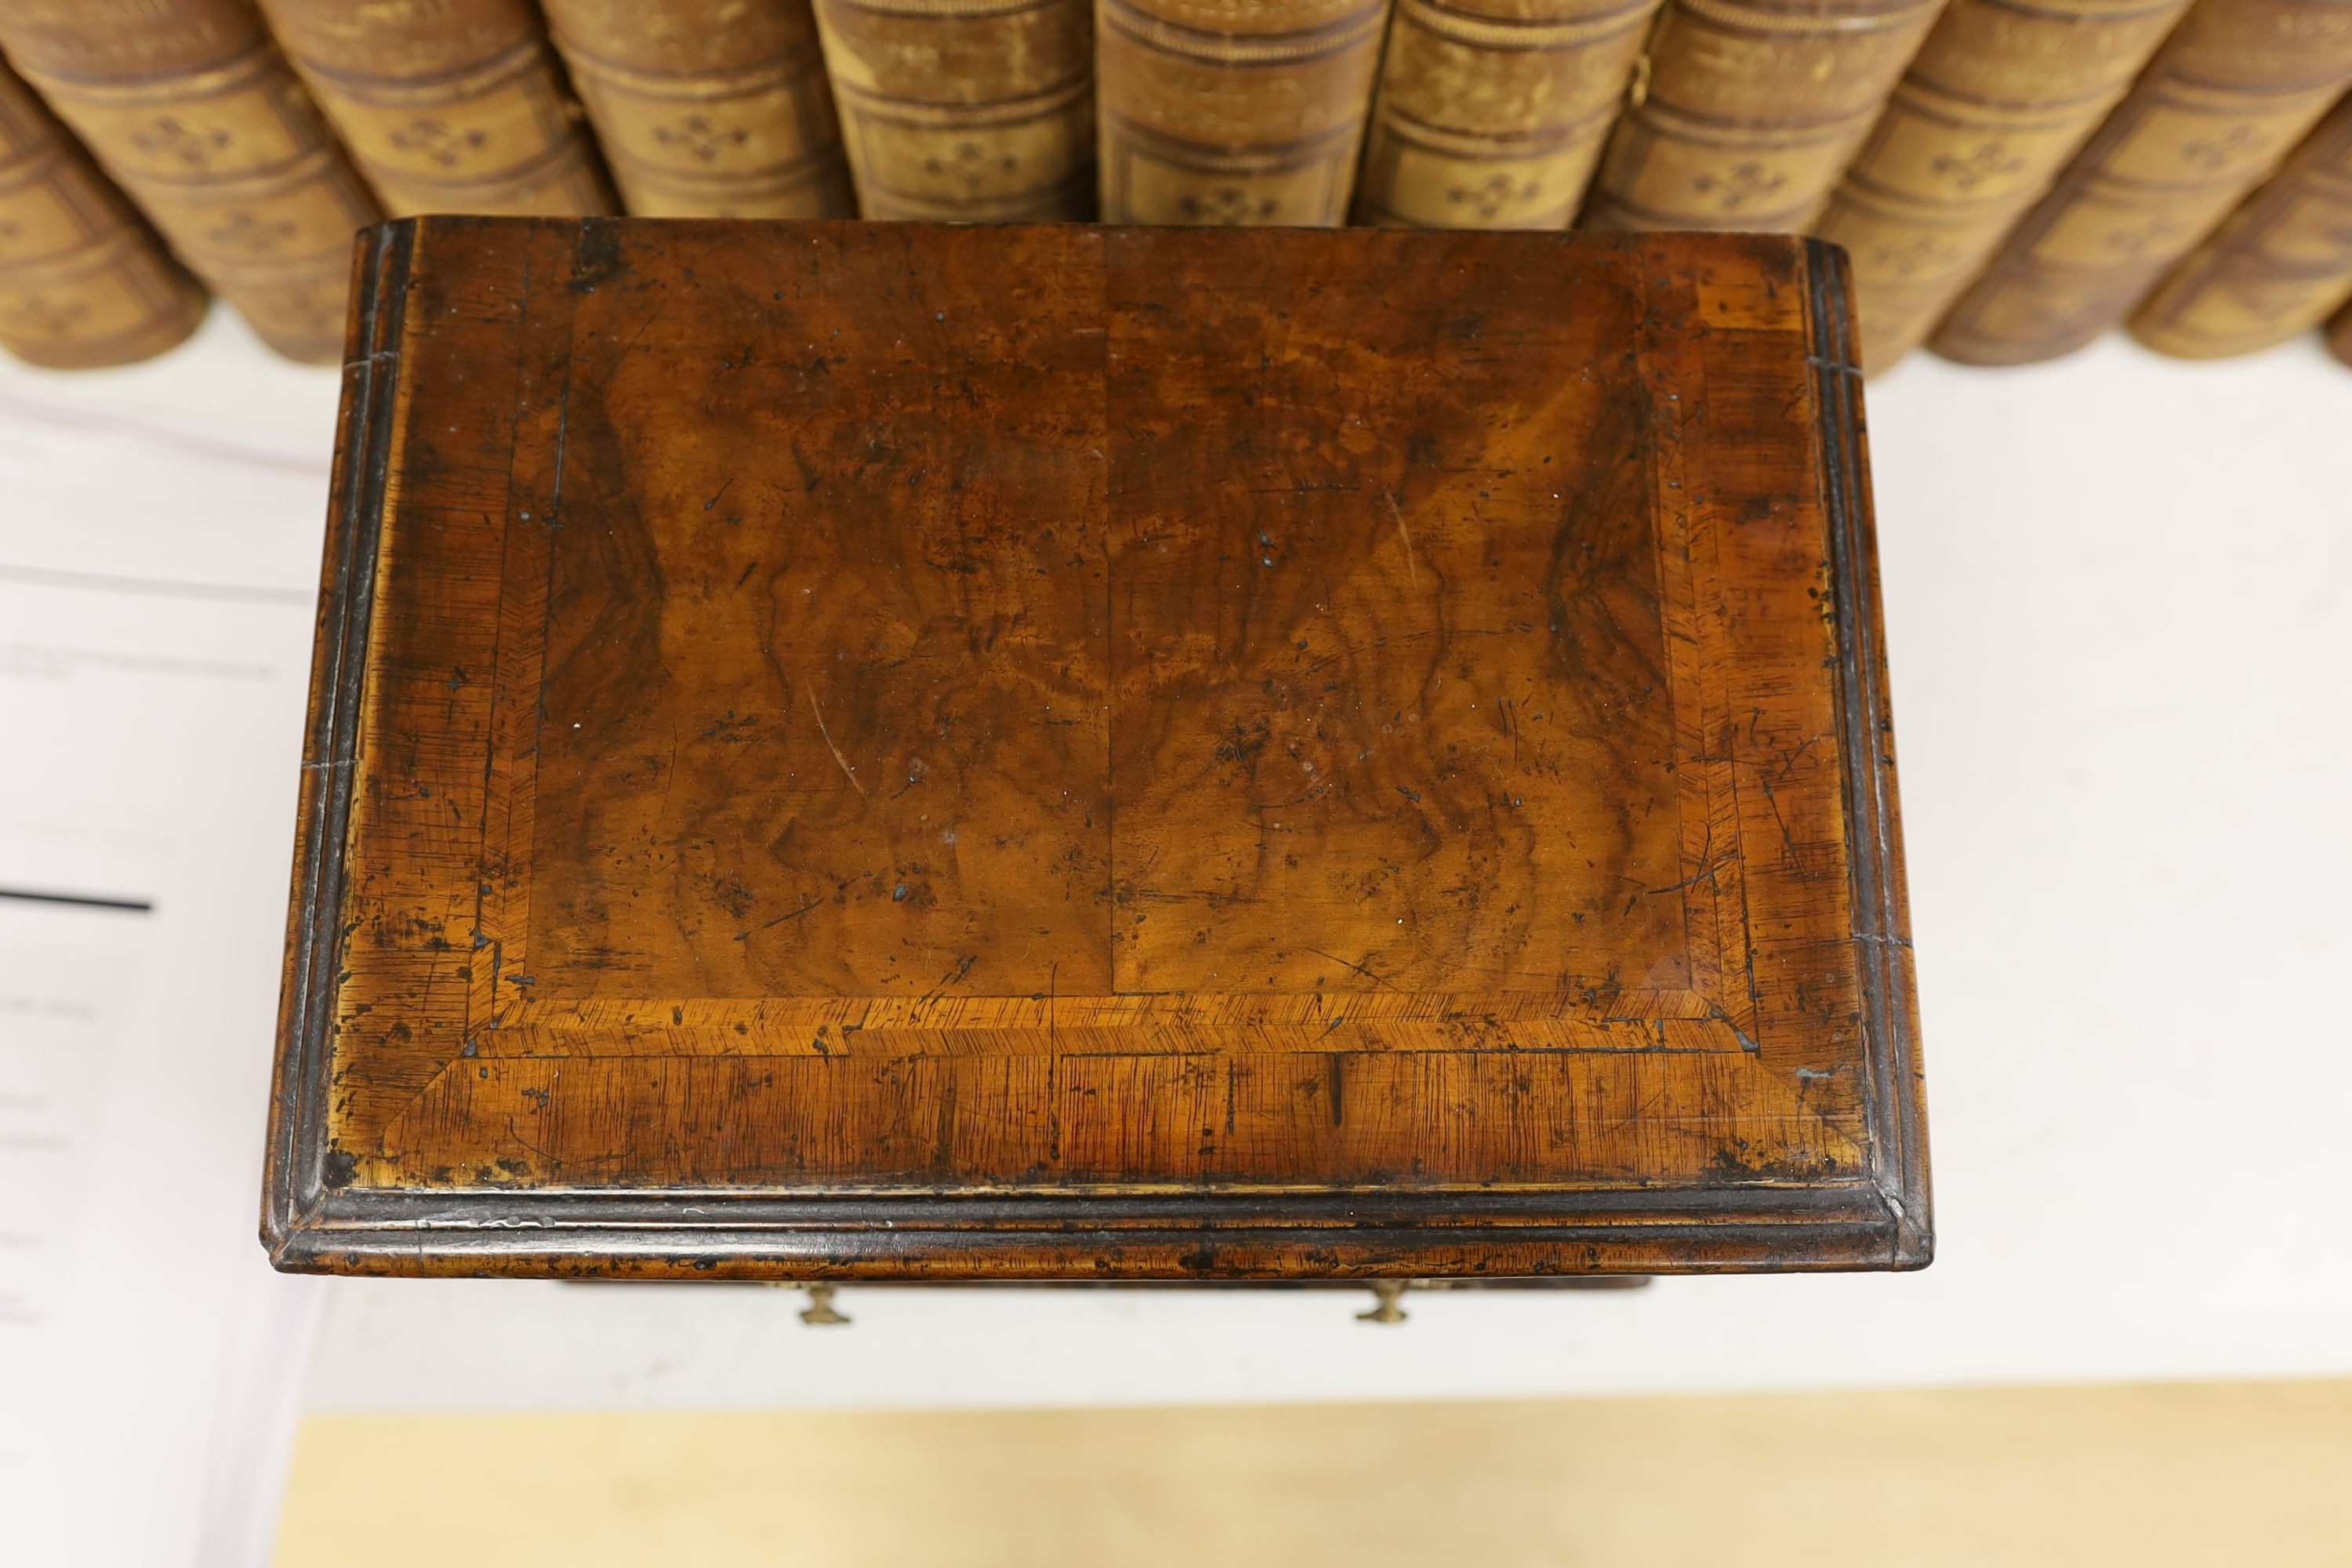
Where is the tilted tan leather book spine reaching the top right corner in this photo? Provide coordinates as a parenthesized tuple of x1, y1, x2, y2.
(1929, 0, 2352, 365)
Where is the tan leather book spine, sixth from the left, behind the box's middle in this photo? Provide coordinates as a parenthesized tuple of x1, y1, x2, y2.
(1096, 0, 1388, 228)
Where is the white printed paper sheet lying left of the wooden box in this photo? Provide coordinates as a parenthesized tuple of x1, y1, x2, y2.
(0, 393, 327, 1568)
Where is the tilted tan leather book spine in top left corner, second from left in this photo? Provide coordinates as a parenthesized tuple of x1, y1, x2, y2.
(0, 0, 383, 365)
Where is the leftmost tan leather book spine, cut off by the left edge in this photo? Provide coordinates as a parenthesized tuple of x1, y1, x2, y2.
(0, 66, 205, 369)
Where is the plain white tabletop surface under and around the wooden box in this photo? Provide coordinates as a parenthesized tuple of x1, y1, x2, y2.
(0, 313, 2352, 1410)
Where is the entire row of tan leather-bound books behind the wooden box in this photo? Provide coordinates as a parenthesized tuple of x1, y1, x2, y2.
(0, 0, 2352, 369)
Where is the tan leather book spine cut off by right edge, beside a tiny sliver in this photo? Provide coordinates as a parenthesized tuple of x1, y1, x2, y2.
(2131, 99, 2352, 360)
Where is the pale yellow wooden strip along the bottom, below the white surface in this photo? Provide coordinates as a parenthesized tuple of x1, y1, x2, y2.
(278, 1382, 2352, 1568)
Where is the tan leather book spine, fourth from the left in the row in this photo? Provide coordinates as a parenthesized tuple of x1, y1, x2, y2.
(546, 0, 856, 219)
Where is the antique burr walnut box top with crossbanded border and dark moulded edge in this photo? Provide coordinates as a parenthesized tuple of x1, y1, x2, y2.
(263, 219, 1929, 1279)
